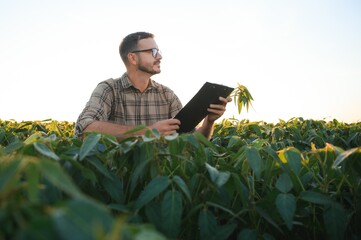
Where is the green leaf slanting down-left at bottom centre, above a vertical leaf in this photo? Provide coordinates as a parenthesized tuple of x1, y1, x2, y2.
(135, 176, 170, 209)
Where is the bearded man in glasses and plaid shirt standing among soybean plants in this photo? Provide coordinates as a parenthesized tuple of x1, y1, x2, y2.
(75, 32, 231, 139)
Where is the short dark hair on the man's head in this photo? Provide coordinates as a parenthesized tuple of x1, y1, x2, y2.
(119, 32, 154, 64)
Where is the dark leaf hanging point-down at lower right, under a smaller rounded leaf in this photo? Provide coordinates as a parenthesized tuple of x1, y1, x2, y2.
(276, 193, 296, 230)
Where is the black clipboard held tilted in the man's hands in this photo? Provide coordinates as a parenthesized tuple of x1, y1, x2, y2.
(174, 82, 234, 133)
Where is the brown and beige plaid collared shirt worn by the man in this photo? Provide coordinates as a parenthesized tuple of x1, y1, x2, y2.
(75, 73, 182, 136)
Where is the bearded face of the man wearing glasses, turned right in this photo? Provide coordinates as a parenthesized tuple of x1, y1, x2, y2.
(136, 38, 162, 75)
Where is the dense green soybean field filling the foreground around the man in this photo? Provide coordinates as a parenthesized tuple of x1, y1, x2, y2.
(0, 118, 361, 240)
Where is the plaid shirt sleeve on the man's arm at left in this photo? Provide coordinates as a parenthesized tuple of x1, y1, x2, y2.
(75, 82, 114, 136)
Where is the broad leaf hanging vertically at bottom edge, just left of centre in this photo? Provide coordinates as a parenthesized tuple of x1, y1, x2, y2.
(162, 190, 183, 239)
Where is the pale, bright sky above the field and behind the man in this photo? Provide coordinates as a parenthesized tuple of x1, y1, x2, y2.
(0, 0, 361, 123)
